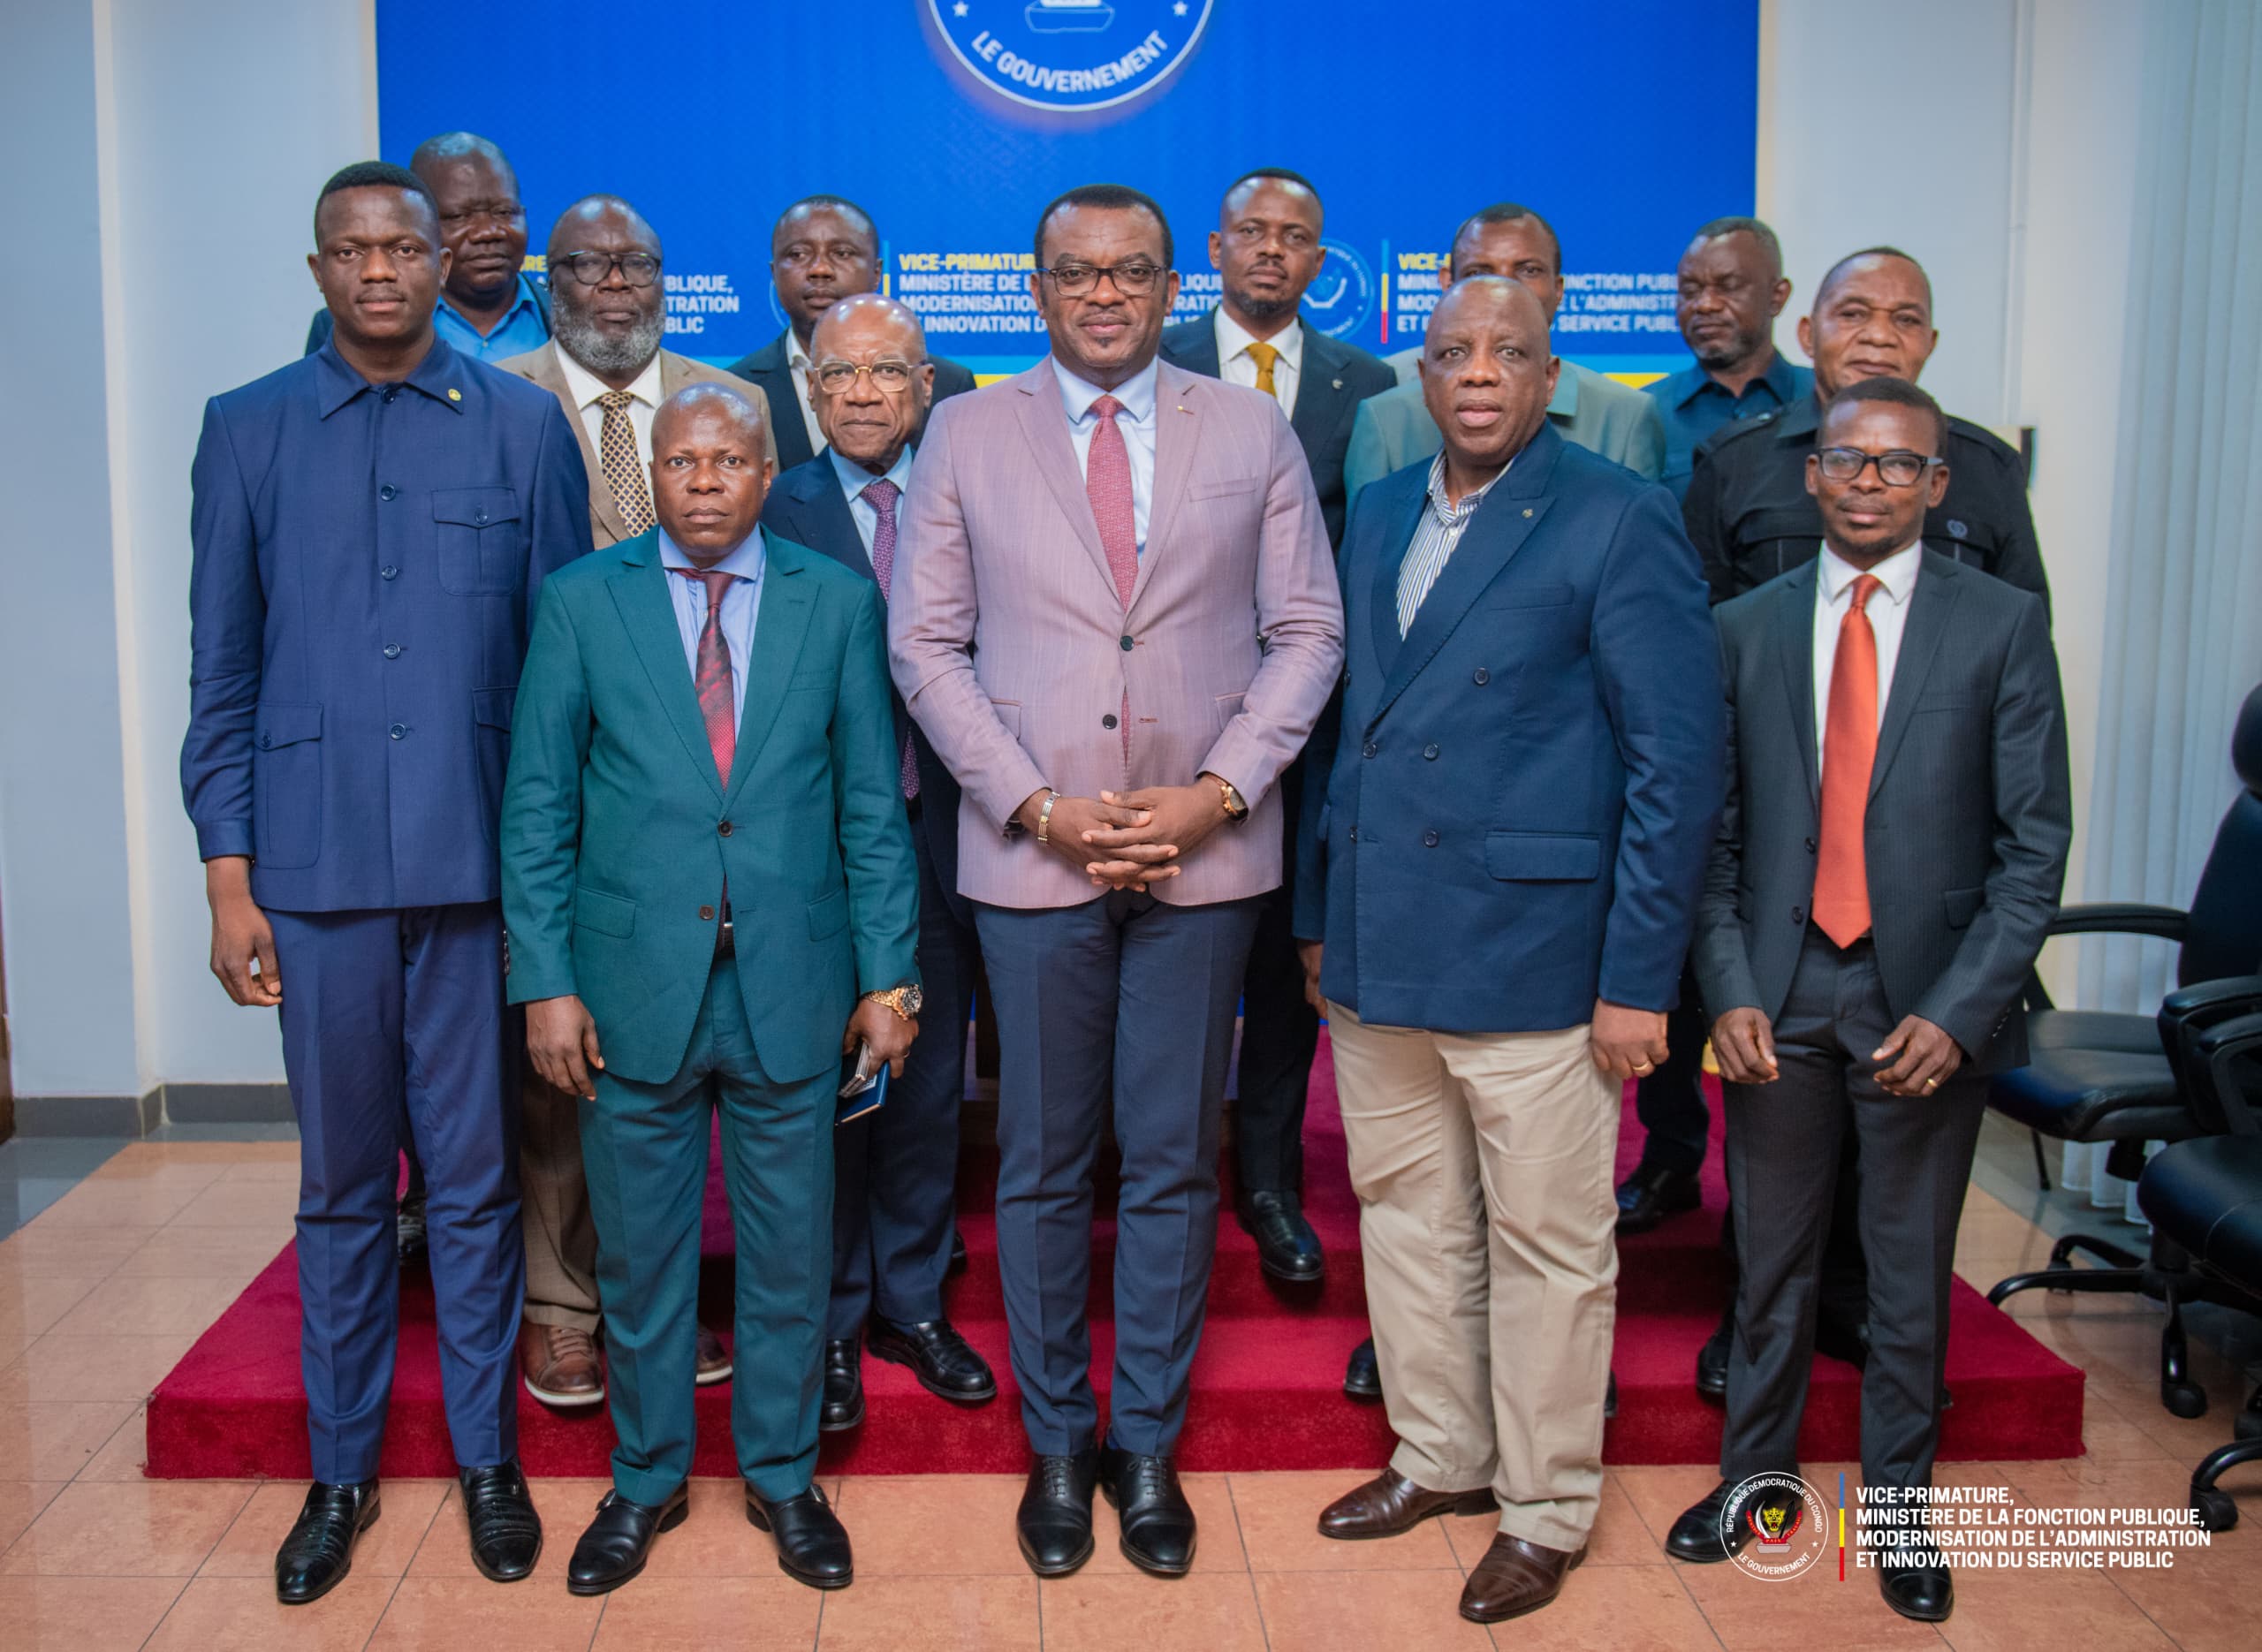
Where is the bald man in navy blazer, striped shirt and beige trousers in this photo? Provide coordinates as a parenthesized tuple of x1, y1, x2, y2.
(1296, 277, 1724, 1623)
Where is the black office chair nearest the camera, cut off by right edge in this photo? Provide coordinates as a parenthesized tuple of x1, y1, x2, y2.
(2136, 1014, 2262, 1532)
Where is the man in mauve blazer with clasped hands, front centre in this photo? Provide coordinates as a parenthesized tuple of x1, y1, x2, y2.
(889, 186, 1344, 1575)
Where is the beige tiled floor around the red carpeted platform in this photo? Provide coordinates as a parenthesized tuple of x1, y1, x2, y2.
(0, 1143, 2262, 1652)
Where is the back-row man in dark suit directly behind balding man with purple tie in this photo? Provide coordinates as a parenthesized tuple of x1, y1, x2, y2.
(731, 194, 975, 473)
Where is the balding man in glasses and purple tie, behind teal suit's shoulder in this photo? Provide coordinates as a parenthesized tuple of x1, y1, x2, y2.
(763, 292, 998, 1433)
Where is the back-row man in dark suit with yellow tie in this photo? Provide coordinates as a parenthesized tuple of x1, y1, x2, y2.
(1163, 168, 1398, 1283)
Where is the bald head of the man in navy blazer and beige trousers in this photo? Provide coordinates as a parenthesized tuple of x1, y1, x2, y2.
(1421, 277, 1556, 480)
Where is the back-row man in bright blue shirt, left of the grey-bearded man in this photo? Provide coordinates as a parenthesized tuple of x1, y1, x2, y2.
(306, 132, 550, 367)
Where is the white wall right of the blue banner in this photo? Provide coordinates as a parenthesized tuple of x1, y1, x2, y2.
(1757, 0, 2146, 996)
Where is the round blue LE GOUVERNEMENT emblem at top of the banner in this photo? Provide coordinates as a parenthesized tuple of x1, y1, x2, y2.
(928, 0, 1217, 116)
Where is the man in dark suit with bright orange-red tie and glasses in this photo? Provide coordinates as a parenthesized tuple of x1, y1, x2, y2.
(1667, 378, 2072, 1623)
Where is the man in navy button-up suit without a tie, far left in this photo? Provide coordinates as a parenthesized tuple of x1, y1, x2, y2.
(181, 161, 590, 1604)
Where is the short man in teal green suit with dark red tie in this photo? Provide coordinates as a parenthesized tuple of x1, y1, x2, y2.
(502, 384, 918, 1595)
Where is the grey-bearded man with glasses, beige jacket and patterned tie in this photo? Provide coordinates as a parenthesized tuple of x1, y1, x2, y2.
(500, 194, 776, 1407)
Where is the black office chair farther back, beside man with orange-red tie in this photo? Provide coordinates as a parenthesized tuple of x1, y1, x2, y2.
(1988, 688, 2262, 1417)
